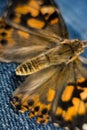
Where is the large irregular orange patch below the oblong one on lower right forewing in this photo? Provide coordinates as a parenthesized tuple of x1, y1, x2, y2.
(55, 98, 86, 121)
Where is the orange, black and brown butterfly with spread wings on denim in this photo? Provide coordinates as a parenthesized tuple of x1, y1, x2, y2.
(0, 0, 87, 130)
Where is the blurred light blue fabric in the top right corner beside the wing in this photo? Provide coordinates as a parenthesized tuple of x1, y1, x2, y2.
(56, 0, 87, 40)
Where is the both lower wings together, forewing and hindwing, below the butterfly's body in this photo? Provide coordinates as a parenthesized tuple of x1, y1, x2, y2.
(11, 54, 87, 130)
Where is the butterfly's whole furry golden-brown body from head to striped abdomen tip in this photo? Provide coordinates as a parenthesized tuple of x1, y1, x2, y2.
(16, 40, 84, 75)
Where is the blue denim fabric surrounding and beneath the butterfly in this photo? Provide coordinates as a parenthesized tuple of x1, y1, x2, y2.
(0, 0, 87, 130)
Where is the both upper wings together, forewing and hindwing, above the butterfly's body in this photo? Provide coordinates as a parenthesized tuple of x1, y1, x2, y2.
(0, 0, 68, 63)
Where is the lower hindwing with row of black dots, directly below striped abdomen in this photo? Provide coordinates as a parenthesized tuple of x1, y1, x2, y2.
(11, 65, 72, 123)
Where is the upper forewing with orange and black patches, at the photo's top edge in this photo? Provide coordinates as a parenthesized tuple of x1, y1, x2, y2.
(4, 0, 68, 38)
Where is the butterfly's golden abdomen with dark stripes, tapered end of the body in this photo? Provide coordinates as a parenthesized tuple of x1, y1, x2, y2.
(16, 54, 50, 75)
